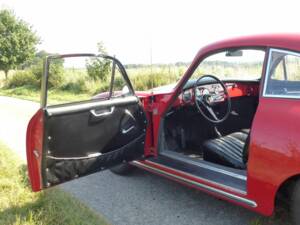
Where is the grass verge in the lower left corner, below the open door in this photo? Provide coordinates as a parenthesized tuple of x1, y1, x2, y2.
(0, 143, 108, 225)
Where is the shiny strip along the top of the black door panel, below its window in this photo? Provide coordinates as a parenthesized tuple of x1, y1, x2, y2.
(45, 96, 139, 116)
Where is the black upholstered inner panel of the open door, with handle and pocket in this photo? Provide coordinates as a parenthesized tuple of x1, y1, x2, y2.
(43, 96, 147, 186)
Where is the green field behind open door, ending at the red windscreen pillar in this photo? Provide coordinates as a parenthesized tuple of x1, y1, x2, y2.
(0, 67, 184, 104)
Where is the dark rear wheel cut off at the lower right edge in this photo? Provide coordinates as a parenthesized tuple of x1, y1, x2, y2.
(290, 180, 300, 225)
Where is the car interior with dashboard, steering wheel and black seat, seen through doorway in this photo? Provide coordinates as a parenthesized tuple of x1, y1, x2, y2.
(160, 49, 264, 189)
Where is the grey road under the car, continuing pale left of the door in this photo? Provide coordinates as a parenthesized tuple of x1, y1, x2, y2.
(0, 96, 286, 225)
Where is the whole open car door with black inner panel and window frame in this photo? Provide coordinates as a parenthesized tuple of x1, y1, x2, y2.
(26, 54, 147, 191)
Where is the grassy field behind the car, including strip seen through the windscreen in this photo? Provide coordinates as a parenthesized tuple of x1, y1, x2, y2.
(0, 62, 261, 105)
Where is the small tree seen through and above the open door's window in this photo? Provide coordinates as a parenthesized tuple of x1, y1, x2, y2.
(86, 42, 111, 81)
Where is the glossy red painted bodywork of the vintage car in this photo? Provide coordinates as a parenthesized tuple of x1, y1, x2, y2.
(27, 34, 300, 216)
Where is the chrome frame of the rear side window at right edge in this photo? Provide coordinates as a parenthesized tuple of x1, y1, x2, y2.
(262, 48, 300, 99)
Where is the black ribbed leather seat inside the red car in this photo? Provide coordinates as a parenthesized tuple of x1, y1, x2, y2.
(203, 129, 250, 169)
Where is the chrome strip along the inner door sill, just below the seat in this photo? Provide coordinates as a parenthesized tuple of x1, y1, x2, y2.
(160, 150, 247, 181)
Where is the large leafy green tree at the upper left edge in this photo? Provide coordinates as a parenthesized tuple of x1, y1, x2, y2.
(0, 10, 39, 79)
